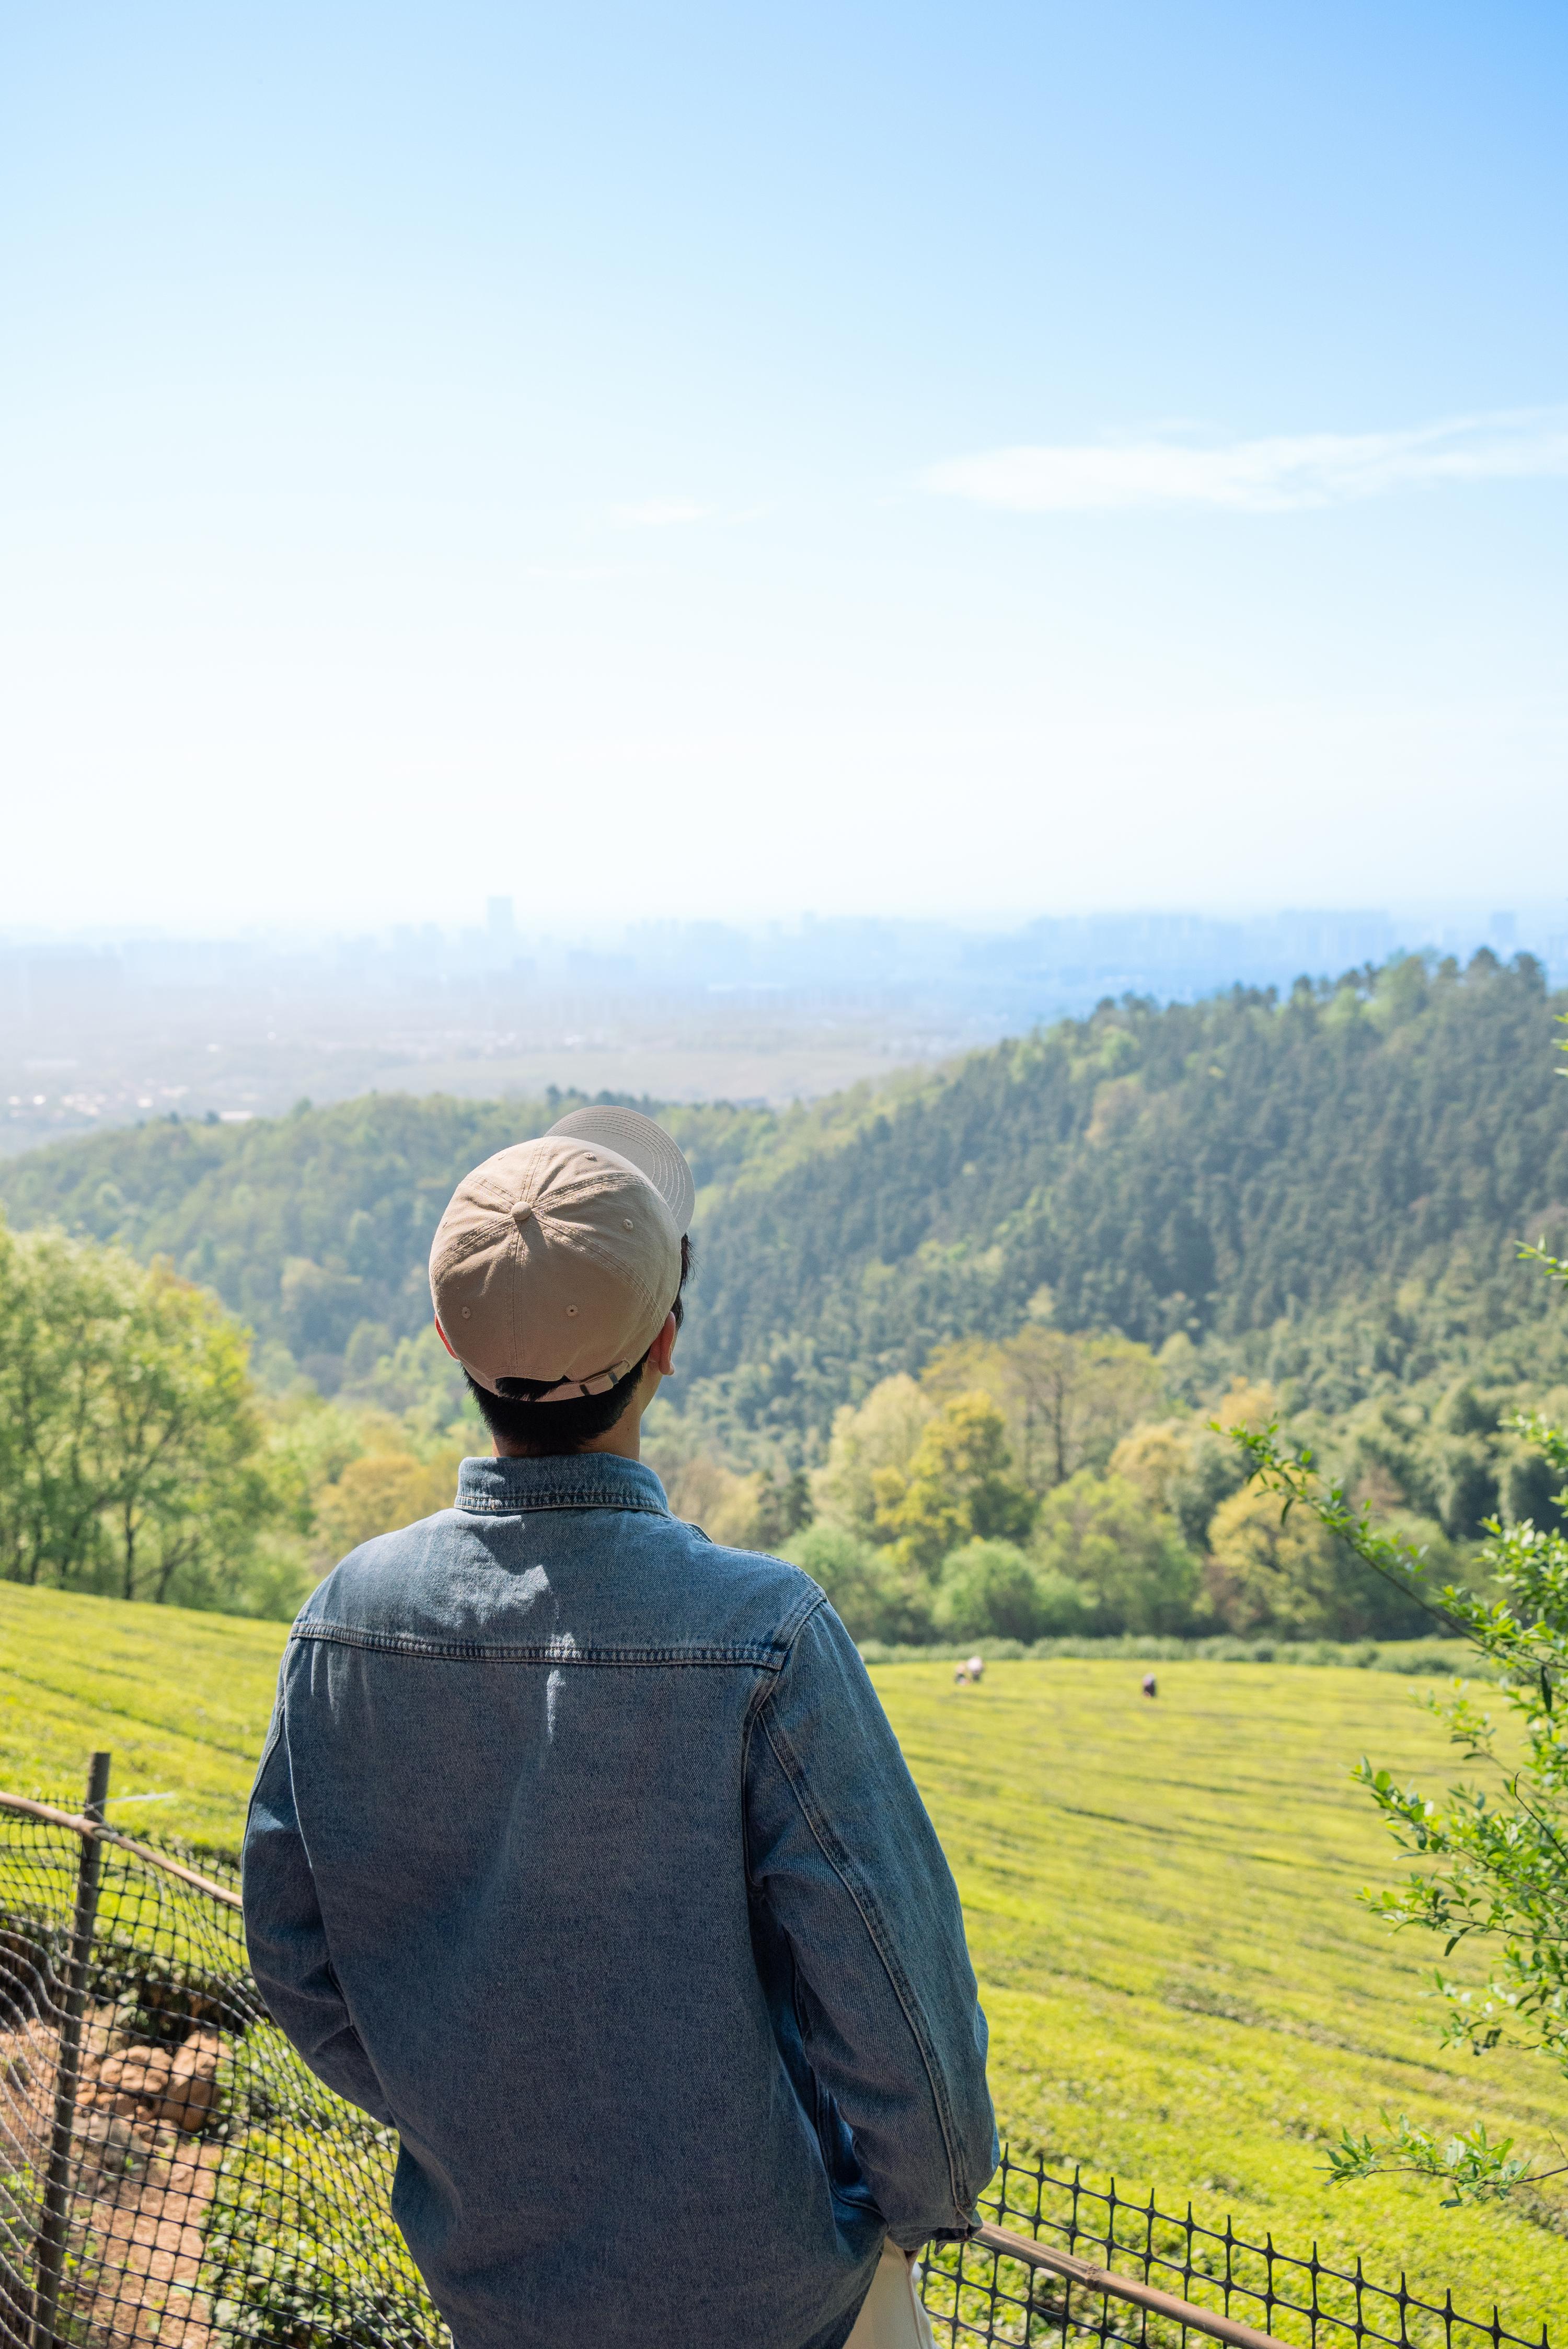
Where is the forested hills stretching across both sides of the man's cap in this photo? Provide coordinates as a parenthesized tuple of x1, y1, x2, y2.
(0, 954, 1568, 1431)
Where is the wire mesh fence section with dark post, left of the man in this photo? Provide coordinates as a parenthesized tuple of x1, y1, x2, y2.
(0, 1766, 448, 2349)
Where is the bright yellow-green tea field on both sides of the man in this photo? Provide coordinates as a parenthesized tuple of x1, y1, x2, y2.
(0, 1585, 1568, 2330)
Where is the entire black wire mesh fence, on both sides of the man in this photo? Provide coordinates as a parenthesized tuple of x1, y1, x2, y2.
(0, 1757, 1552, 2349)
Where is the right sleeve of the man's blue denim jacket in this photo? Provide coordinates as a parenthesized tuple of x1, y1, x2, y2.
(746, 1604, 998, 2250)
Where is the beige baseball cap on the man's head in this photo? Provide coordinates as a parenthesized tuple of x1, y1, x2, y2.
(430, 1109, 695, 1402)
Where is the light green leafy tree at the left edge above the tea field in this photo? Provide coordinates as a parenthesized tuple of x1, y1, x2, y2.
(0, 1224, 286, 1607)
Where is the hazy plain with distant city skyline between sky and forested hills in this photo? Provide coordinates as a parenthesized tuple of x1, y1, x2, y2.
(0, 895, 1568, 1154)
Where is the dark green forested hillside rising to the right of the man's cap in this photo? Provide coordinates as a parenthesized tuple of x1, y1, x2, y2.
(688, 954, 1568, 1423)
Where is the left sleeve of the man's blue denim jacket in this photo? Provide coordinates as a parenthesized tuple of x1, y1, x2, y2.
(242, 1665, 397, 2128)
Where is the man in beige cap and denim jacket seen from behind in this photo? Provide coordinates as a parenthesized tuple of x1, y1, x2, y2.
(244, 1109, 995, 2349)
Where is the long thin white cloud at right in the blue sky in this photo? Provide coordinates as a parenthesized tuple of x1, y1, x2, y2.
(925, 409, 1568, 514)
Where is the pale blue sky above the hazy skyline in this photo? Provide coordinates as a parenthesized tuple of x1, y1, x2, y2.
(0, 0, 1568, 928)
